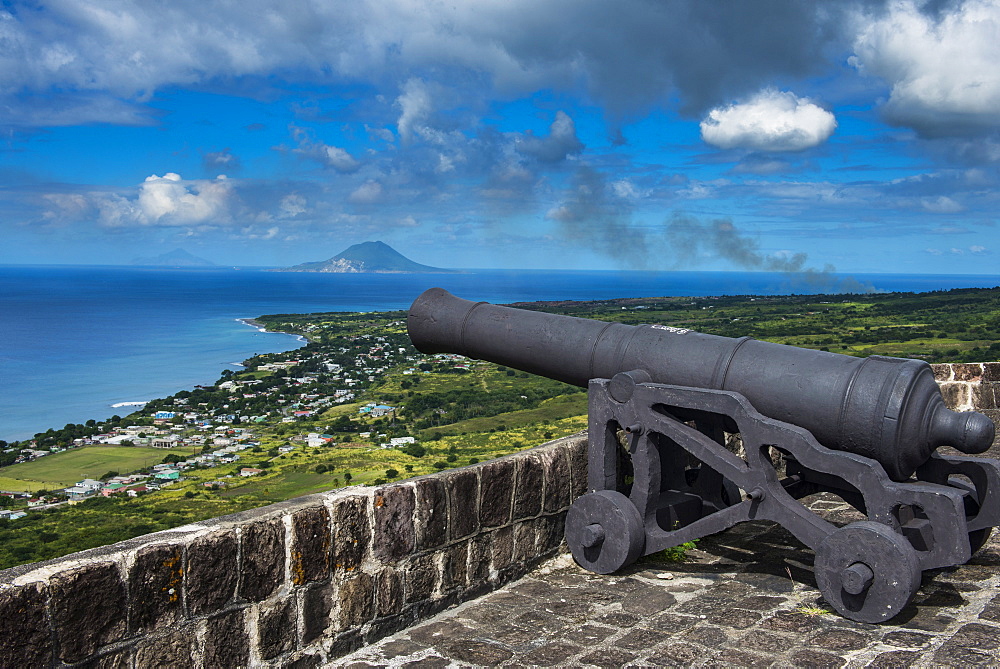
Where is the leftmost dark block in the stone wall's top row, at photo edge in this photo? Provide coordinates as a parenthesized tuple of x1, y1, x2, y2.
(0, 583, 52, 667)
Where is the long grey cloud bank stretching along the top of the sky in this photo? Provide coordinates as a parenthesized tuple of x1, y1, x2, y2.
(0, 0, 855, 127)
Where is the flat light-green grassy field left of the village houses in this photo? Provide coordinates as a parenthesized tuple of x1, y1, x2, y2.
(0, 446, 190, 492)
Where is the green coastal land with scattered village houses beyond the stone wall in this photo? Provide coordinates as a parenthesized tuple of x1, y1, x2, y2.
(0, 288, 1000, 567)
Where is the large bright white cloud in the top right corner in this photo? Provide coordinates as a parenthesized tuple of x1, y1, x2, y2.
(850, 0, 1000, 136)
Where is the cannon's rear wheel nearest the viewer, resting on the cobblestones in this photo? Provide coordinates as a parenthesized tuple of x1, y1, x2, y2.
(815, 520, 921, 623)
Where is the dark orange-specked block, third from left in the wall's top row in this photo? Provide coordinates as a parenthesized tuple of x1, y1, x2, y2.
(128, 544, 184, 634)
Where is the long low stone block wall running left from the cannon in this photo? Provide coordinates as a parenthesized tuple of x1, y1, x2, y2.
(0, 436, 586, 668)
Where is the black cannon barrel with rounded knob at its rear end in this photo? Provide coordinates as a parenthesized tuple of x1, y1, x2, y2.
(407, 288, 995, 481)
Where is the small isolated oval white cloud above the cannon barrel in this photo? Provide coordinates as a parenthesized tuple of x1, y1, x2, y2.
(701, 88, 837, 151)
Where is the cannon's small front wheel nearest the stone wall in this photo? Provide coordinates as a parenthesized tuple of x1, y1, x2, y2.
(566, 490, 646, 574)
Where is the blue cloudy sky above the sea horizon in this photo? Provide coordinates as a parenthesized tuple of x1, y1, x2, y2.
(0, 0, 1000, 274)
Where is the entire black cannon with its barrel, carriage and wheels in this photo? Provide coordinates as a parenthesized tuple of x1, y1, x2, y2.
(407, 288, 1000, 622)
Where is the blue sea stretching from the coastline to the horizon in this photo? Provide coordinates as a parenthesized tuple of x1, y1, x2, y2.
(0, 266, 1000, 441)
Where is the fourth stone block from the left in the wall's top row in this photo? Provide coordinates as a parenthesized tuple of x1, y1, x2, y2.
(184, 531, 240, 616)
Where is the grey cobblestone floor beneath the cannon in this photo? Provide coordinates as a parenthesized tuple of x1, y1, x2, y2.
(331, 500, 1000, 669)
